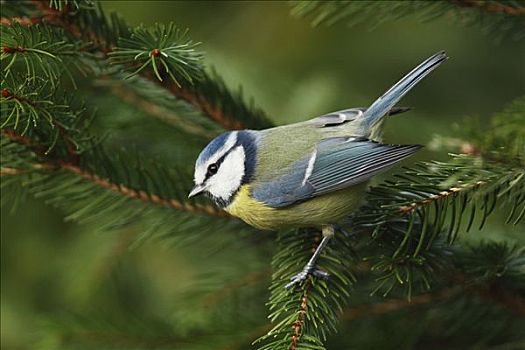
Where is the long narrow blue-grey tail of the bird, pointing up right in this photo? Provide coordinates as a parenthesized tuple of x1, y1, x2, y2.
(360, 51, 448, 130)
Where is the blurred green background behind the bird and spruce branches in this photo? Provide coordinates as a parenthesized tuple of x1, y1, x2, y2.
(1, 1, 525, 349)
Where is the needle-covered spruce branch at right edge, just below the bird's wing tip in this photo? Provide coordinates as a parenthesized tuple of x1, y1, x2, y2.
(356, 155, 525, 243)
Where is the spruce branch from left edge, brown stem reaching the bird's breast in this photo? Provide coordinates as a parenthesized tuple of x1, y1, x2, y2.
(1, 76, 227, 217)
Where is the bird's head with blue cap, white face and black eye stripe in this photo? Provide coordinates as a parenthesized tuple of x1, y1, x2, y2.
(188, 130, 256, 207)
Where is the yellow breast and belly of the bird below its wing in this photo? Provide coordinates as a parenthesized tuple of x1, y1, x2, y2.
(224, 183, 367, 230)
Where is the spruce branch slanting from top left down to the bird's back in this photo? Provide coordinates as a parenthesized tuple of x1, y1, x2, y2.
(32, 3, 273, 129)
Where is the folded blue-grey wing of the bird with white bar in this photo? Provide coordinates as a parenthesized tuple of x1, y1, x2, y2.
(252, 137, 421, 208)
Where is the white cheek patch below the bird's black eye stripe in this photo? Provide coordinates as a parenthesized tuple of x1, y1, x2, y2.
(208, 146, 245, 201)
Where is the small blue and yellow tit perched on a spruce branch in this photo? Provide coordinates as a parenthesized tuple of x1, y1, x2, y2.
(188, 51, 448, 288)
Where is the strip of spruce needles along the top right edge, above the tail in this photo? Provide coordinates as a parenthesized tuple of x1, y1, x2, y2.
(292, 0, 525, 41)
